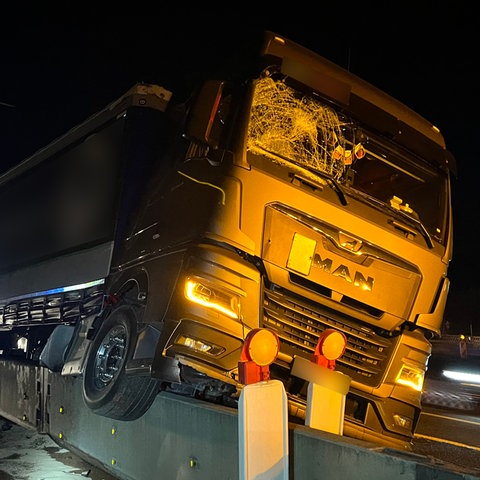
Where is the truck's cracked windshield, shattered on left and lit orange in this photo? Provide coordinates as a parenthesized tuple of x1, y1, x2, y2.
(247, 76, 448, 243)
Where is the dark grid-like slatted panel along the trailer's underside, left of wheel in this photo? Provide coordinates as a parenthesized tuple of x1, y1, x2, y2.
(0, 286, 104, 330)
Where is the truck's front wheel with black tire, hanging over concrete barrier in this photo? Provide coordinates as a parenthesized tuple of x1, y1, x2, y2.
(83, 303, 159, 420)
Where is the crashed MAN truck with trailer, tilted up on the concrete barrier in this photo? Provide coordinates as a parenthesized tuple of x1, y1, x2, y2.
(0, 31, 456, 450)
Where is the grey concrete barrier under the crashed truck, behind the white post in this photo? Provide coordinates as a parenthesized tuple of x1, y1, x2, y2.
(0, 362, 480, 480)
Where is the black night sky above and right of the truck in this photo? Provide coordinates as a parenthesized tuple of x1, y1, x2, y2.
(0, 9, 480, 335)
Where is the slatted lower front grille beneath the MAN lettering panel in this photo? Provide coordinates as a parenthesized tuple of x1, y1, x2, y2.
(263, 287, 396, 386)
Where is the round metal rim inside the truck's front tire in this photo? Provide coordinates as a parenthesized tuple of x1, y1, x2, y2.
(93, 325, 127, 390)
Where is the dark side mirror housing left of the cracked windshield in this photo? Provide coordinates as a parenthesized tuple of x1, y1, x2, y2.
(186, 80, 225, 149)
